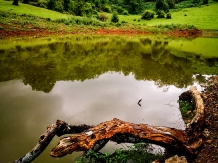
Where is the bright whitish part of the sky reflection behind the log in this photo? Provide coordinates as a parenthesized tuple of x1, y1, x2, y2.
(51, 73, 184, 127)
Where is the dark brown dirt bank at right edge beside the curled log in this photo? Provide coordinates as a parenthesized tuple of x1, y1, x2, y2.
(188, 76, 218, 163)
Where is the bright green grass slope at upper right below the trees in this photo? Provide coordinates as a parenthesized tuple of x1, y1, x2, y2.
(119, 2, 218, 30)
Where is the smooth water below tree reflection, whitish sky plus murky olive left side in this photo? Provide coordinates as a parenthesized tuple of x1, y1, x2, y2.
(0, 73, 189, 162)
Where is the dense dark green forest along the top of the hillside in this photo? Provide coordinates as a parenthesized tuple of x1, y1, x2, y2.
(13, 0, 213, 16)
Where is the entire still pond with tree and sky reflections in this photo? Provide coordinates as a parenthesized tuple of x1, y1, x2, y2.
(0, 35, 218, 163)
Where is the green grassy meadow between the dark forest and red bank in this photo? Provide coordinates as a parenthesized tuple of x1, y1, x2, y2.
(0, 0, 218, 32)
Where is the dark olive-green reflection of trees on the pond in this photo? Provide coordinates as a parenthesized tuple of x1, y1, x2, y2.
(0, 37, 217, 92)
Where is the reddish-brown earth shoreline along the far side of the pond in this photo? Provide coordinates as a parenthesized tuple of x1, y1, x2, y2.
(0, 24, 218, 39)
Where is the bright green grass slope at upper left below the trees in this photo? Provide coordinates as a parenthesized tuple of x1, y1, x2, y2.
(0, 0, 69, 20)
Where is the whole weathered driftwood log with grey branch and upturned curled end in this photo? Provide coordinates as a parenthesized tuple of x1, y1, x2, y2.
(14, 87, 204, 163)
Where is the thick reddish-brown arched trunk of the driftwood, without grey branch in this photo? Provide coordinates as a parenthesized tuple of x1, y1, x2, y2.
(51, 118, 190, 157)
